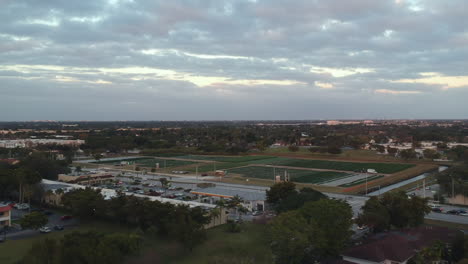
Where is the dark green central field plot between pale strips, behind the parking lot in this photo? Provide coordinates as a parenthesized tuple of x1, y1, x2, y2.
(228, 166, 348, 184)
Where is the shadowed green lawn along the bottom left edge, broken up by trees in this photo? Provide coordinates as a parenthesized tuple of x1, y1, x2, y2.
(0, 223, 272, 264)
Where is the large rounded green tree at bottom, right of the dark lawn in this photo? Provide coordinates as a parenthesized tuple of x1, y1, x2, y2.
(269, 199, 353, 264)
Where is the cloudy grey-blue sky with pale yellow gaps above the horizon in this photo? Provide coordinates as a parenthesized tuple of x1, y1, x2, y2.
(0, 0, 468, 121)
